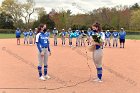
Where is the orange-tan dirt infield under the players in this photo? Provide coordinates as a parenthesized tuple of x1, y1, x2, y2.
(0, 39, 140, 93)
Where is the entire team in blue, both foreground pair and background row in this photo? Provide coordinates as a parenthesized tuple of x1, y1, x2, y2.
(16, 23, 126, 82)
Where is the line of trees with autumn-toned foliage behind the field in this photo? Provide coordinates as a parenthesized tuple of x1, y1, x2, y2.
(0, 0, 140, 31)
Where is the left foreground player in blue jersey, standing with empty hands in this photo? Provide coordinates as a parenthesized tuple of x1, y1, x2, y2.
(36, 24, 51, 80)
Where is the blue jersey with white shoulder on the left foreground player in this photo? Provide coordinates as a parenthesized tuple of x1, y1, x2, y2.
(36, 32, 50, 52)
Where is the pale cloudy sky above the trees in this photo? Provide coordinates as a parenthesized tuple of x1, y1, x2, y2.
(0, 0, 140, 14)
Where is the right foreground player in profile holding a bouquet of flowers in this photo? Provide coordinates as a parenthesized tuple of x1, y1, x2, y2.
(92, 23, 104, 82)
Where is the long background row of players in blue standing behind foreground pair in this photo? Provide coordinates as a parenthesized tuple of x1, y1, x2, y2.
(16, 28, 126, 48)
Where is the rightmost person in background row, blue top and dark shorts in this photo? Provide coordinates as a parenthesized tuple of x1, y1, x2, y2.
(119, 28, 126, 48)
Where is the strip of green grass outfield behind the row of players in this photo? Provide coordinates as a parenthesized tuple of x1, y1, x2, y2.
(0, 34, 140, 40)
